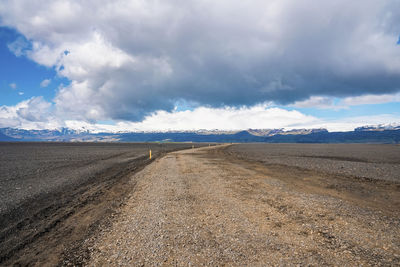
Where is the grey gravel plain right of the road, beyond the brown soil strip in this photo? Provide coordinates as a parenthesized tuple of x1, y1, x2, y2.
(227, 144, 400, 182)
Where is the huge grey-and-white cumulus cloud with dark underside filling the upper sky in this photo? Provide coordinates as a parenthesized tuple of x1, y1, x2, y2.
(0, 0, 400, 121)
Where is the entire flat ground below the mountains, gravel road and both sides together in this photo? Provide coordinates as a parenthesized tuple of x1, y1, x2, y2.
(0, 144, 400, 266)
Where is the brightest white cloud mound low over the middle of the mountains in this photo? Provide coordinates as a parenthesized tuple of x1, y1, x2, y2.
(117, 105, 317, 131)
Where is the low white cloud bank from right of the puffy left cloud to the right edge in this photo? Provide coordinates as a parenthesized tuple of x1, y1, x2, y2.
(66, 105, 400, 132)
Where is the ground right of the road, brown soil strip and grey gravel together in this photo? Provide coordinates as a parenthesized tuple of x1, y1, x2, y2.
(216, 144, 400, 217)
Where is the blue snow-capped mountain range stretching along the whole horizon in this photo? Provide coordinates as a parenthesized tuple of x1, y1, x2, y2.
(0, 125, 400, 144)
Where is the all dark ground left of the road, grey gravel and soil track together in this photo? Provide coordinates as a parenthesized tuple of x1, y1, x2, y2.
(0, 143, 203, 265)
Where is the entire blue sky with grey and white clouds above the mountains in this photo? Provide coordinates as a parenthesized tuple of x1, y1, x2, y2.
(0, 0, 400, 131)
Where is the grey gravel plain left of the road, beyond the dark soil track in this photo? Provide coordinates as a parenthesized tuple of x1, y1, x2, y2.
(0, 142, 191, 214)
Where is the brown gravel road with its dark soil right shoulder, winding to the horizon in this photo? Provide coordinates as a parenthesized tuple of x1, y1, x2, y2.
(87, 148, 400, 266)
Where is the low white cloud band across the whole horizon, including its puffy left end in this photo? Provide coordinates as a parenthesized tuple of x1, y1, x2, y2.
(0, 97, 400, 132)
